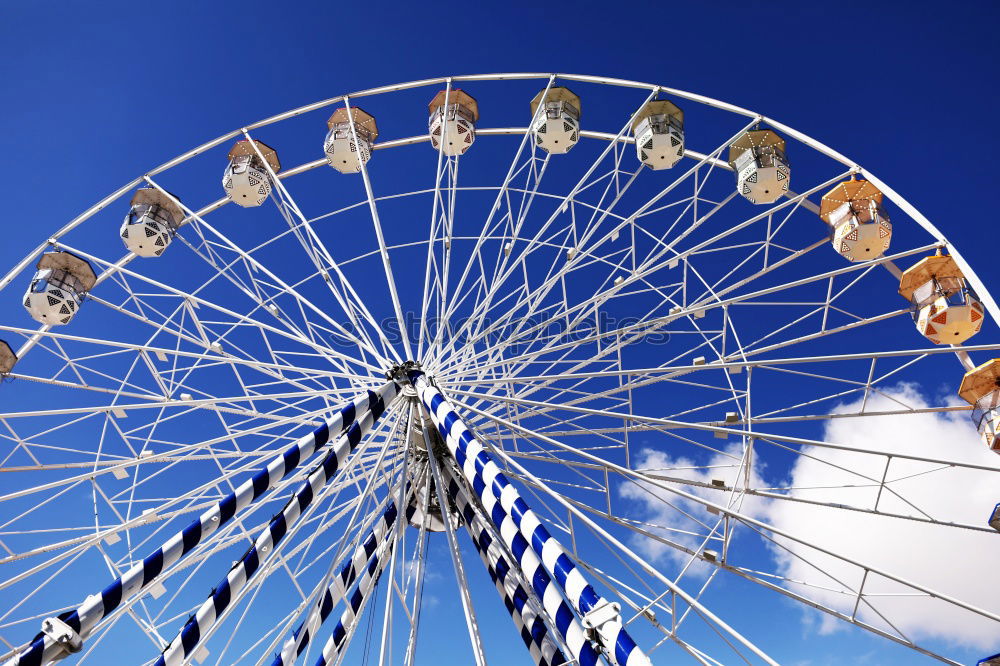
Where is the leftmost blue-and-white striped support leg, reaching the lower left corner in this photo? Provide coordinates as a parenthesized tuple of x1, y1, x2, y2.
(4, 382, 400, 666)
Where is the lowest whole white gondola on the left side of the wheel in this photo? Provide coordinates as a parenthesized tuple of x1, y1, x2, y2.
(24, 252, 97, 326)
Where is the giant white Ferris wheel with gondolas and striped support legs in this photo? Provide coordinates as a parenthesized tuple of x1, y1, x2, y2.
(0, 74, 1000, 666)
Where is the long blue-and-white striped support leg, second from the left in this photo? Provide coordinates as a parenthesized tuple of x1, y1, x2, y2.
(156, 400, 394, 666)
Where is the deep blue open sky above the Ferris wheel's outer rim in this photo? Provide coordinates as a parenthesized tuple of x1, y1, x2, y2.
(0, 2, 1000, 664)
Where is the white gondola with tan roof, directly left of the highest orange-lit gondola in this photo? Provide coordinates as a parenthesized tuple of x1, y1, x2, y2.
(729, 129, 792, 204)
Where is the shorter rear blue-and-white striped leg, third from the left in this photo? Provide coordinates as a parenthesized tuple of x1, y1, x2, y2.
(271, 501, 416, 666)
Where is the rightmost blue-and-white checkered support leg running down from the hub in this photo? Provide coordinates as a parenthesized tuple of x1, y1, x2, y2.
(408, 370, 651, 666)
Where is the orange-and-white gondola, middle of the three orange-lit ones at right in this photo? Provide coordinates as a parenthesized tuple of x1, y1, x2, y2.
(899, 249, 983, 345)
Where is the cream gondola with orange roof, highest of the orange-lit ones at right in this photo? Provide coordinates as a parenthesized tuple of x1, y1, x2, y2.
(819, 176, 892, 261)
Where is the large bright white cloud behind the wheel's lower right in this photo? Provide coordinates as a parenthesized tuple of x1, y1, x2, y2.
(622, 385, 1000, 650)
